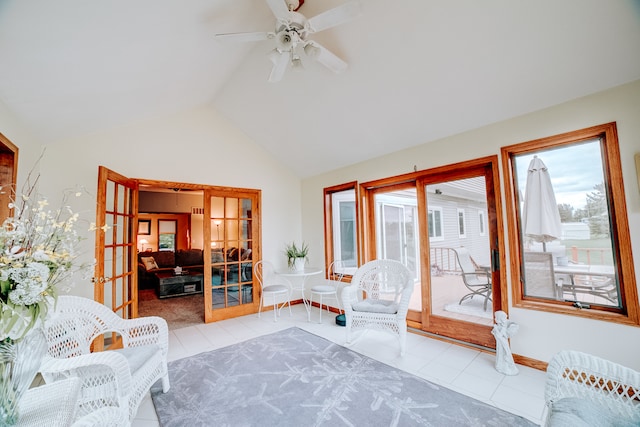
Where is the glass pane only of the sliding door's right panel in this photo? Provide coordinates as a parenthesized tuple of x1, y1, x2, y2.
(425, 177, 493, 325)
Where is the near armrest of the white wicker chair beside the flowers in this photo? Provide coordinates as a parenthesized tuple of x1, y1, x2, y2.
(40, 351, 132, 398)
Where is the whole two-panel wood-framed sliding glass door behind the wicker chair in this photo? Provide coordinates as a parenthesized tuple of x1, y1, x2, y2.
(361, 157, 506, 348)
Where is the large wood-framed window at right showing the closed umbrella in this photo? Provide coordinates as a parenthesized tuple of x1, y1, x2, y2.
(502, 123, 639, 324)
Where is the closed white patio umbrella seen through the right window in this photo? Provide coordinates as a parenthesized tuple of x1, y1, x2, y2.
(522, 156, 562, 251)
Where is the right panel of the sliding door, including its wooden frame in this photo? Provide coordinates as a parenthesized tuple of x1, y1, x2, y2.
(418, 158, 506, 348)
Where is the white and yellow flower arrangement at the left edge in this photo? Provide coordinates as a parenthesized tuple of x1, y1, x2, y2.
(0, 171, 89, 342)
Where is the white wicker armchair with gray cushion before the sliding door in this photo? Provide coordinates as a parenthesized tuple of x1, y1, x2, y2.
(342, 259, 414, 355)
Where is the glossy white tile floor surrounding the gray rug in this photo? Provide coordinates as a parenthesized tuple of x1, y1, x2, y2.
(133, 304, 545, 427)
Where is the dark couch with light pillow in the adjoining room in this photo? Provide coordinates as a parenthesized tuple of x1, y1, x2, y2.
(138, 249, 204, 289)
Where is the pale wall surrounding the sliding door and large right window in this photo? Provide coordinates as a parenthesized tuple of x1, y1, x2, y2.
(302, 81, 640, 370)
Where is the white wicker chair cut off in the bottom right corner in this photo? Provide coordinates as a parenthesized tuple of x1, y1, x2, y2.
(544, 351, 640, 426)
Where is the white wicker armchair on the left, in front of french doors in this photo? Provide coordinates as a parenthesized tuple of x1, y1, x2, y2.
(41, 296, 169, 425)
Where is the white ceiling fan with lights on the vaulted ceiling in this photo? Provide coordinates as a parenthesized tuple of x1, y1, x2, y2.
(215, 0, 361, 82)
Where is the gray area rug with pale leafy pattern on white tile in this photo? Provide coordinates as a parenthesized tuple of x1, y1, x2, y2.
(151, 328, 535, 427)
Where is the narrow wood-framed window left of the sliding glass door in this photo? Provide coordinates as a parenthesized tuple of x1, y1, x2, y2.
(324, 182, 358, 275)
